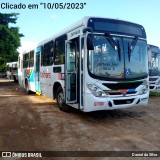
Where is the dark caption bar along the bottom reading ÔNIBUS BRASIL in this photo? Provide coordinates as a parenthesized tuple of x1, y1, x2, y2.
(0, 151, 160, 157)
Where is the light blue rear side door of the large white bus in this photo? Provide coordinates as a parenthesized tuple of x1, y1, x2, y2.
(35, 48, 41, 95)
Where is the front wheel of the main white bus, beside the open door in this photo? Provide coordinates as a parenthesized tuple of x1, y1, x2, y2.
(56, 87, 70, 112)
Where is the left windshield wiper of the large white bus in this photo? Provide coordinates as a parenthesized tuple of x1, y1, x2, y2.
(105, 33, 121, 60)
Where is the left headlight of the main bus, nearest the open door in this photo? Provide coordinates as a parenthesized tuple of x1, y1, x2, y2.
(87, 84, 106, 97)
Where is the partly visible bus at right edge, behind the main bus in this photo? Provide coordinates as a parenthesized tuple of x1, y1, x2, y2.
(148, 44, 160, 92)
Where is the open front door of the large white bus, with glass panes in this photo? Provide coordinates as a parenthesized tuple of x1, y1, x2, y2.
(65, 41, 77, 104)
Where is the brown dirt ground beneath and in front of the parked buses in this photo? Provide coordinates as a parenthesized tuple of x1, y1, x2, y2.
(0, 79, 160, 160)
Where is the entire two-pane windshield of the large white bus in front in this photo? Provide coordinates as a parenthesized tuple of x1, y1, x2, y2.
(88, 34, 148, 80)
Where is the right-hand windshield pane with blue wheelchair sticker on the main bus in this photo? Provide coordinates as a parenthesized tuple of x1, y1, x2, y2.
(123, 38, 148, 79)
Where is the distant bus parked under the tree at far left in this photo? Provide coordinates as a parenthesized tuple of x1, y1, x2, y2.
(6, 61, 18, 82)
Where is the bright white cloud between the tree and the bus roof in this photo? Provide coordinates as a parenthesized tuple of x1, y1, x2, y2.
(17, 41, 38, 53)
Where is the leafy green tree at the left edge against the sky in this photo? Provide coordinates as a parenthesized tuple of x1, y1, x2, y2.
(0, 13, 23, 71)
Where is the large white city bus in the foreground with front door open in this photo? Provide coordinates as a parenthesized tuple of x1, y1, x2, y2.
(18, 17, 149, 112)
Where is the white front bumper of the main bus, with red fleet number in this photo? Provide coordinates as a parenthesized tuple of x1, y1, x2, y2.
(83, 92, 149, 112)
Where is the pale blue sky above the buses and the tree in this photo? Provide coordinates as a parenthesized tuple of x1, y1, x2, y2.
(0, 0, 160, 52)
